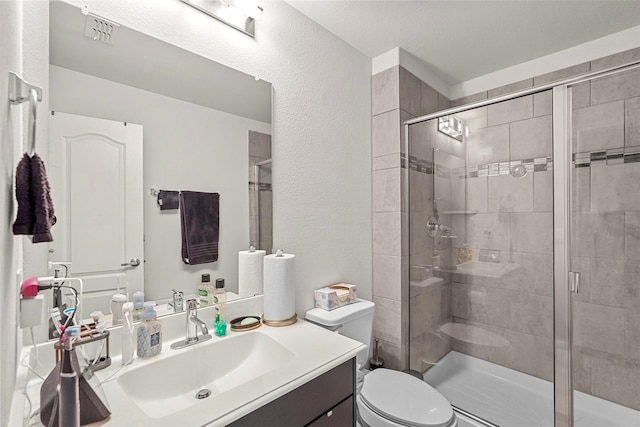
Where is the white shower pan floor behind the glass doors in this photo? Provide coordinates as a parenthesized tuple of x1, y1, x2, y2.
(424, 351, 640, 427)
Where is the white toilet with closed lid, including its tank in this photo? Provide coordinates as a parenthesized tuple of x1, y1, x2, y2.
(305, 299, 458, 427)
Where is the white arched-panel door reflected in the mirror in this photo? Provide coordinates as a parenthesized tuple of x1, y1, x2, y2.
(49, 112, 144, 326)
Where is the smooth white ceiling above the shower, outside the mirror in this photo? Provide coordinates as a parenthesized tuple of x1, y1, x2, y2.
(287, 0, 640, 86)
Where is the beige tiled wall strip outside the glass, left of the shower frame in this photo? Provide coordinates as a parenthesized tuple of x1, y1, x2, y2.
(371, 66, 449, 369)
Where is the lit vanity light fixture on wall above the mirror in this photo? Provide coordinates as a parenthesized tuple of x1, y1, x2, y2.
(181, 0, 262, 37)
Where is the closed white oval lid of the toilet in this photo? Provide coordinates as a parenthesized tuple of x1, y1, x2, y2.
(360, 369, 453, 427)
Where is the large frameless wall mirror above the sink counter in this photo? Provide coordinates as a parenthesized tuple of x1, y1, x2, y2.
(30, 2, 272, 342)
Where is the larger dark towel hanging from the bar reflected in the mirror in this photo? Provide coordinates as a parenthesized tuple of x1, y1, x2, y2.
(180, 191, 220, 265)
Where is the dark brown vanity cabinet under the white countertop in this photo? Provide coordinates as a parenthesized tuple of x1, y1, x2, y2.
(230, 358, 355, 427)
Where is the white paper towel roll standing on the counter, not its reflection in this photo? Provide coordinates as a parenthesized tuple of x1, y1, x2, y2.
(263, 254, 296, 322)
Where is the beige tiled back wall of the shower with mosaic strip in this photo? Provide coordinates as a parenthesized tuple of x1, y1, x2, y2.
(438, 49, 640, 409)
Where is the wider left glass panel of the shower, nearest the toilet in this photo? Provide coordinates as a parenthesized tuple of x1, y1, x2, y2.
(408, 91, 554, 427)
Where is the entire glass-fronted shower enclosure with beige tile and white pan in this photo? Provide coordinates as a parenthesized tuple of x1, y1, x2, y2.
(405, 64, 640, 427)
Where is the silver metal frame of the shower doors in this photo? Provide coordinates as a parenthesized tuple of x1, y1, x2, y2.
(401, 61, 640, 427)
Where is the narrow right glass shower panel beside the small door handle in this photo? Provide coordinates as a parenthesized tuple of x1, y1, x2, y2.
(558, 68, 640, 427)
